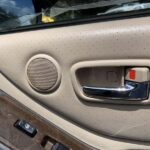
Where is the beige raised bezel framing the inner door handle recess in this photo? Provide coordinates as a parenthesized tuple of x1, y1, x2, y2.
(70, 59, 150, 103)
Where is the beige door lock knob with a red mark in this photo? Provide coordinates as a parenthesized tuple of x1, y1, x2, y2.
(125, 67, 150, 82)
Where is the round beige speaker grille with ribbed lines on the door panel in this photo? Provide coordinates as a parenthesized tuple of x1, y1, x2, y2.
(27, 58, 58, 92)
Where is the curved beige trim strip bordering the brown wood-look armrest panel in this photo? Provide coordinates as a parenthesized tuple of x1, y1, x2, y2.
(0, 74, 150, 150)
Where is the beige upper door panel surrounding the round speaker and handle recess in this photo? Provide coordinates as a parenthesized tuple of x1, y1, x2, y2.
(0, 17, 150, 148)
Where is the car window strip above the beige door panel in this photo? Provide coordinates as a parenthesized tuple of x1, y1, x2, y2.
(0, 0, 150, 32)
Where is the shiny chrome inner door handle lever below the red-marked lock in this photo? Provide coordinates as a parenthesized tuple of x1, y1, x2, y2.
(83, 81, 149, 101)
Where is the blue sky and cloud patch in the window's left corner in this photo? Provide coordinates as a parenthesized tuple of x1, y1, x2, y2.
(0, 0, 35, 30)
